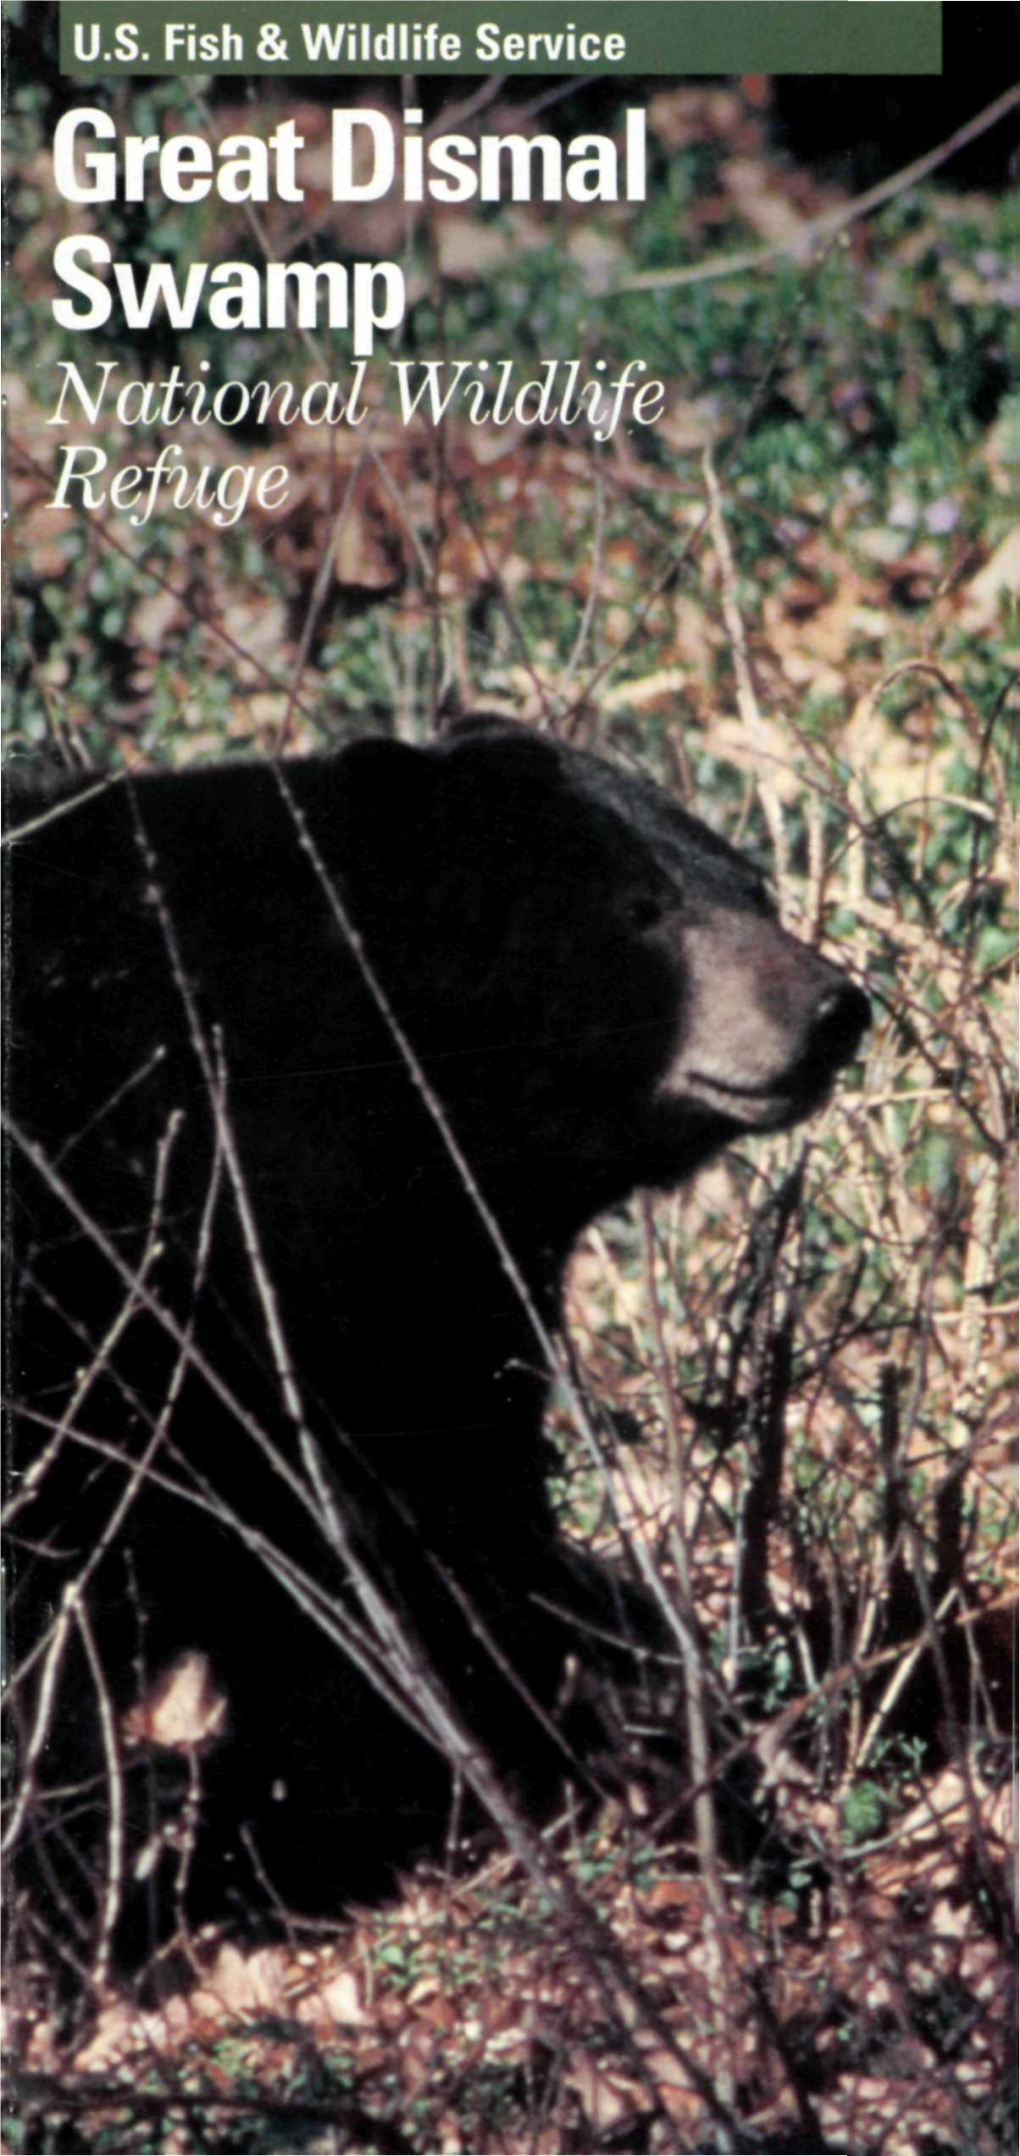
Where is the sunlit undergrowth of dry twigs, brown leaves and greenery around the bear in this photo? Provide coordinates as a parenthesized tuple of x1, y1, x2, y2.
(6, 46, 1020, 2156)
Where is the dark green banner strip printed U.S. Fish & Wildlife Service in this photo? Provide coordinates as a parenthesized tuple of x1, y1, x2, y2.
(60, 0, 942, 80)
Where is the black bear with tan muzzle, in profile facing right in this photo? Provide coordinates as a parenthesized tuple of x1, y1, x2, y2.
(9, 720, 867, 1977)
